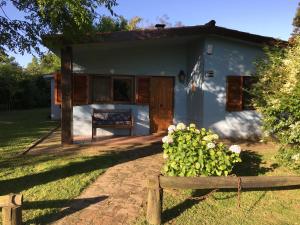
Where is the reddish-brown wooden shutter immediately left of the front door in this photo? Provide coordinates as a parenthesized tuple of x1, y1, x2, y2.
(136, 77, 150, 104)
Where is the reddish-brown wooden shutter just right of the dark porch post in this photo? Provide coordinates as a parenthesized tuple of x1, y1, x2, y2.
(73, 75, 89, 105)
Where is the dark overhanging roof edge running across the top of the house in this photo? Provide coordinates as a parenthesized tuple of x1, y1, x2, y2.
(43, 20, 287, 46)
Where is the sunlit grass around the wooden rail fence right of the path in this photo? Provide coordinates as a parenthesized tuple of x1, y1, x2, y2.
(136, 144, 300, 225)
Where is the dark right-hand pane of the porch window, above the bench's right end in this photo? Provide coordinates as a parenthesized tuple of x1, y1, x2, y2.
(113, 77, 134, 102)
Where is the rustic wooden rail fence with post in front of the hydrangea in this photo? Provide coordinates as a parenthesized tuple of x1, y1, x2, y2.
(147, 176, 300, 225)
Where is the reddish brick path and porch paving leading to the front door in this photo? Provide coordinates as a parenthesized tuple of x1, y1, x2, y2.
(29, 132, 163, 225)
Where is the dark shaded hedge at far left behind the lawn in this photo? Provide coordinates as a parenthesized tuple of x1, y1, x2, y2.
(0, 54, 51, 110)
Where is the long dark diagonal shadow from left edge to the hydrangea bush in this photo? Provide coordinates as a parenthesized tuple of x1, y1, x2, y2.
(0, 143, 161, 195)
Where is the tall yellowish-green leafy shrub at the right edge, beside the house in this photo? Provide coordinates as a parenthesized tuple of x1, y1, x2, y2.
(252, 36, 300, 171)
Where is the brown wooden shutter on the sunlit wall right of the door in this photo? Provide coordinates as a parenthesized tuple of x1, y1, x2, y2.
(226, 76, 243, 111)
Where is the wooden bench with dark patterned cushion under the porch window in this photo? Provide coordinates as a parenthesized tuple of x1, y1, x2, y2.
(92, 109, 133, 140)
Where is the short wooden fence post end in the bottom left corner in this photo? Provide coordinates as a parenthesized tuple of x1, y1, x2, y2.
(0, 194, 23, 225)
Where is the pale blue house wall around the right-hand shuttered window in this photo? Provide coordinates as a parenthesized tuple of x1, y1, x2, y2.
(202, 37, 263, 138)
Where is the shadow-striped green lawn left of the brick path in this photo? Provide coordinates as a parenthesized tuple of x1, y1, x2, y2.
(0, 109, 115, 224)
